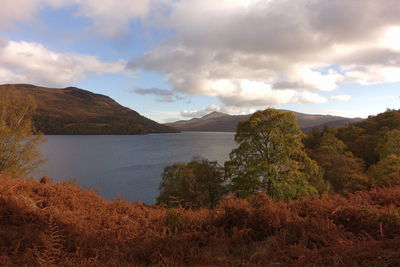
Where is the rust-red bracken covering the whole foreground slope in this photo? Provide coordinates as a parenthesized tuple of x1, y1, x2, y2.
(0, 177, 400, 266)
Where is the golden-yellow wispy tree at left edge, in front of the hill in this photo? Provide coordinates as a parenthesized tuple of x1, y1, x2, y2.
(0, 88, 43, 176)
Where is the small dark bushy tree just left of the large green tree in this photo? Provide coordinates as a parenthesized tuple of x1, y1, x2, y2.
(157, 159, 226, 208)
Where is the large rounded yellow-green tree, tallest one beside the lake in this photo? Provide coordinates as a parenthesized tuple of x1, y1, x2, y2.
(225, 109, 326, 199)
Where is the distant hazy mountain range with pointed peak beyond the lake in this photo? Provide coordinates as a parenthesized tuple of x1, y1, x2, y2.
(166, 111, 362, 132)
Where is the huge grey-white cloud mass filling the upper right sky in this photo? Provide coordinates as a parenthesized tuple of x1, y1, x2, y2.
(128, 0, 400, 107)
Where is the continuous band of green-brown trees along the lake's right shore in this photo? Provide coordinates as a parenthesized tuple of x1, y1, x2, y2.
(158, 109, 400, 208)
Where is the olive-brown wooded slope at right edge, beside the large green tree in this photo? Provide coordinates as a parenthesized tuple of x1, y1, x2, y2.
(304, 110, 400, 194)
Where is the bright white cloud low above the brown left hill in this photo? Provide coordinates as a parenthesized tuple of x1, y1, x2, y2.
(0, 38, 125, 86)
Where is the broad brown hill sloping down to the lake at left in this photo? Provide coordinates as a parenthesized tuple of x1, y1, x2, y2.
(0, 84, 178, 134)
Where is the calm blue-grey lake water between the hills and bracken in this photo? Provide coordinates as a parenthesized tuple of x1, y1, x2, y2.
(36, 132, 236, 204)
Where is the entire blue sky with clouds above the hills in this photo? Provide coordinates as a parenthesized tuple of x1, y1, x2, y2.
(0, 0, 400, 122)
